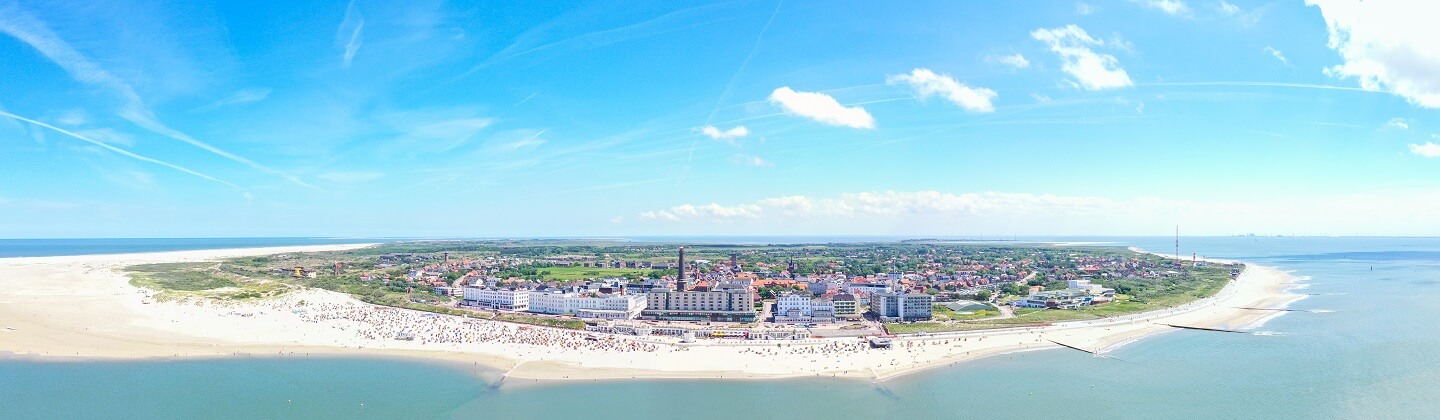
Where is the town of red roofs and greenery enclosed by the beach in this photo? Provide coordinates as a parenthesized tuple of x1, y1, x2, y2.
(194, 242, 1238, 341)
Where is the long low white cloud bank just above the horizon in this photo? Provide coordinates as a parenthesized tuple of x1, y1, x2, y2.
(635, 189, 1440, 236)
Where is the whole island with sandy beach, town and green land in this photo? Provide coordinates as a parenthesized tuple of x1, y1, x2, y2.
(0, 240, 1300, 380)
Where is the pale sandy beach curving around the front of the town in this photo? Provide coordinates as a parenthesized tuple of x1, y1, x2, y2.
(0, 245, 1303, 380)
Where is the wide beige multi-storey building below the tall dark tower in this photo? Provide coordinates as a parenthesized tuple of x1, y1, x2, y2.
(641, 285, 756, 322)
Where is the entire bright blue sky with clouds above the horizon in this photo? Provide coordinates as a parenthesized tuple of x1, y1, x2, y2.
(0, 0, 1440, 237)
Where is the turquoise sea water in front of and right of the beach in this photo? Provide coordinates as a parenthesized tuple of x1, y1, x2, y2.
(0, 237, 1440, 419)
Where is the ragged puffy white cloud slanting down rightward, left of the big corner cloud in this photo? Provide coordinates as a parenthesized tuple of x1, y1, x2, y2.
(1030, 24, 1133, 91)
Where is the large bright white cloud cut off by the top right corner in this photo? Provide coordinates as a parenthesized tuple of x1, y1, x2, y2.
(1306, 0, 1440, 108)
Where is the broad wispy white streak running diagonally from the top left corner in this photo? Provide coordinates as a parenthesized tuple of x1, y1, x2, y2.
(0, 3, 318, 190)
